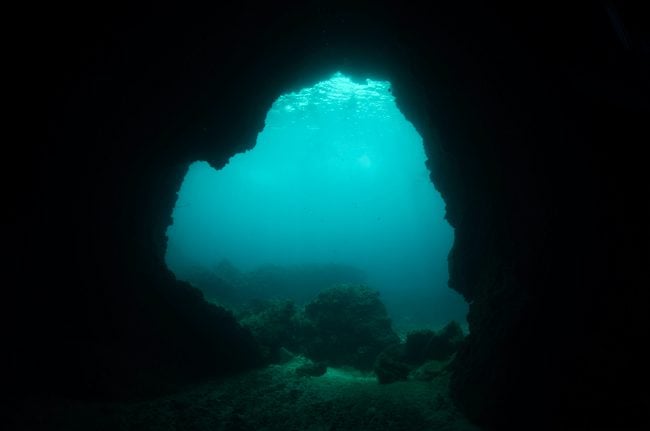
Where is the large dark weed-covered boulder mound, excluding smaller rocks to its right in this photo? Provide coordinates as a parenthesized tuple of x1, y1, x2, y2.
(240, 284, 399, 371)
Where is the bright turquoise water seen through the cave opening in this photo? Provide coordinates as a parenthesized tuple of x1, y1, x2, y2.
(167, 73, 467, 327)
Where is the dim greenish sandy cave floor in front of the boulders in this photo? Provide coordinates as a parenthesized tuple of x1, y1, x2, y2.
(15, 357, 478, 431)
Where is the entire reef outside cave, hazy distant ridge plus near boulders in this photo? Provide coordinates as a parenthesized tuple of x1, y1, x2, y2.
(180, 260, 464, 383)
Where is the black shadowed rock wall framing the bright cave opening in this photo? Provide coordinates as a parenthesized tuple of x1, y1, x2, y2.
(13, 2, 650, 426)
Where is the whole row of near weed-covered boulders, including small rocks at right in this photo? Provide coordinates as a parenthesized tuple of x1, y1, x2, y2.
(239, 284, 464, 383)
